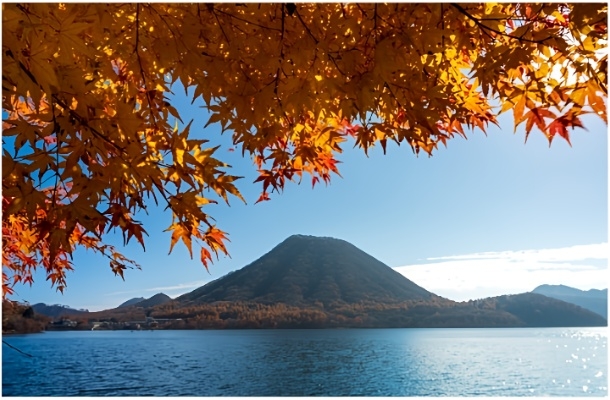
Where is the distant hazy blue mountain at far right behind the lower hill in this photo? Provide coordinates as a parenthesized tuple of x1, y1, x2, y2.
(532, 285, 608, 319)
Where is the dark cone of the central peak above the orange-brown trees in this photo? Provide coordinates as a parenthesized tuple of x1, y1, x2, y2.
(176, 235, 439, 305)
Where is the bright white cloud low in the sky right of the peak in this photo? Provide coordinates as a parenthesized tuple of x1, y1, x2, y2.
(394, 243, 609, 301)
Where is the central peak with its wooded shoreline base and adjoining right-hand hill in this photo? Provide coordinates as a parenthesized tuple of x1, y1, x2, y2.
(61, 235, 607, 329)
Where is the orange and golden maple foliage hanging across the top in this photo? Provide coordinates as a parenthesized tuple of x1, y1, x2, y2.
(2, 3, 608, 295)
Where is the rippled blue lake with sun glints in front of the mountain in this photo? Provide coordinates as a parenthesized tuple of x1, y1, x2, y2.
(2, 328, 608, 396)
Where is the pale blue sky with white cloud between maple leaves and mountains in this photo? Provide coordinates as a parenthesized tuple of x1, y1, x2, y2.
(5, 90, 609, 311)
